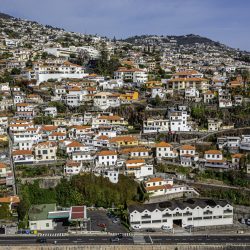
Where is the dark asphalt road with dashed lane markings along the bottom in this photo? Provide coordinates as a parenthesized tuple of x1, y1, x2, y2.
(0, 235, 250, 246)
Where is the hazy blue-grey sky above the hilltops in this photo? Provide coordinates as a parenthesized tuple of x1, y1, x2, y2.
(0, 0, 250, 51)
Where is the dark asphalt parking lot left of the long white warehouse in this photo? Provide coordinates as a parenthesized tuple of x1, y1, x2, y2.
(87, 210, 127, 233)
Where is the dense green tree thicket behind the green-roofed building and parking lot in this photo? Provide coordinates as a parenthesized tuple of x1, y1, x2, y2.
(18, 173, 145, 227)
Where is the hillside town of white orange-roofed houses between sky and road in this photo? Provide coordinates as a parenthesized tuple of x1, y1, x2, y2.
(0, 12, 250, 241)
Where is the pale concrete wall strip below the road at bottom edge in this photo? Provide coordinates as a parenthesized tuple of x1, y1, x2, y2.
(0, 244, 250, 250)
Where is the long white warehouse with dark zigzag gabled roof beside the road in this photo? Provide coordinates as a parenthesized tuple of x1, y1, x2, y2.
(128, 198, 233, 229)
